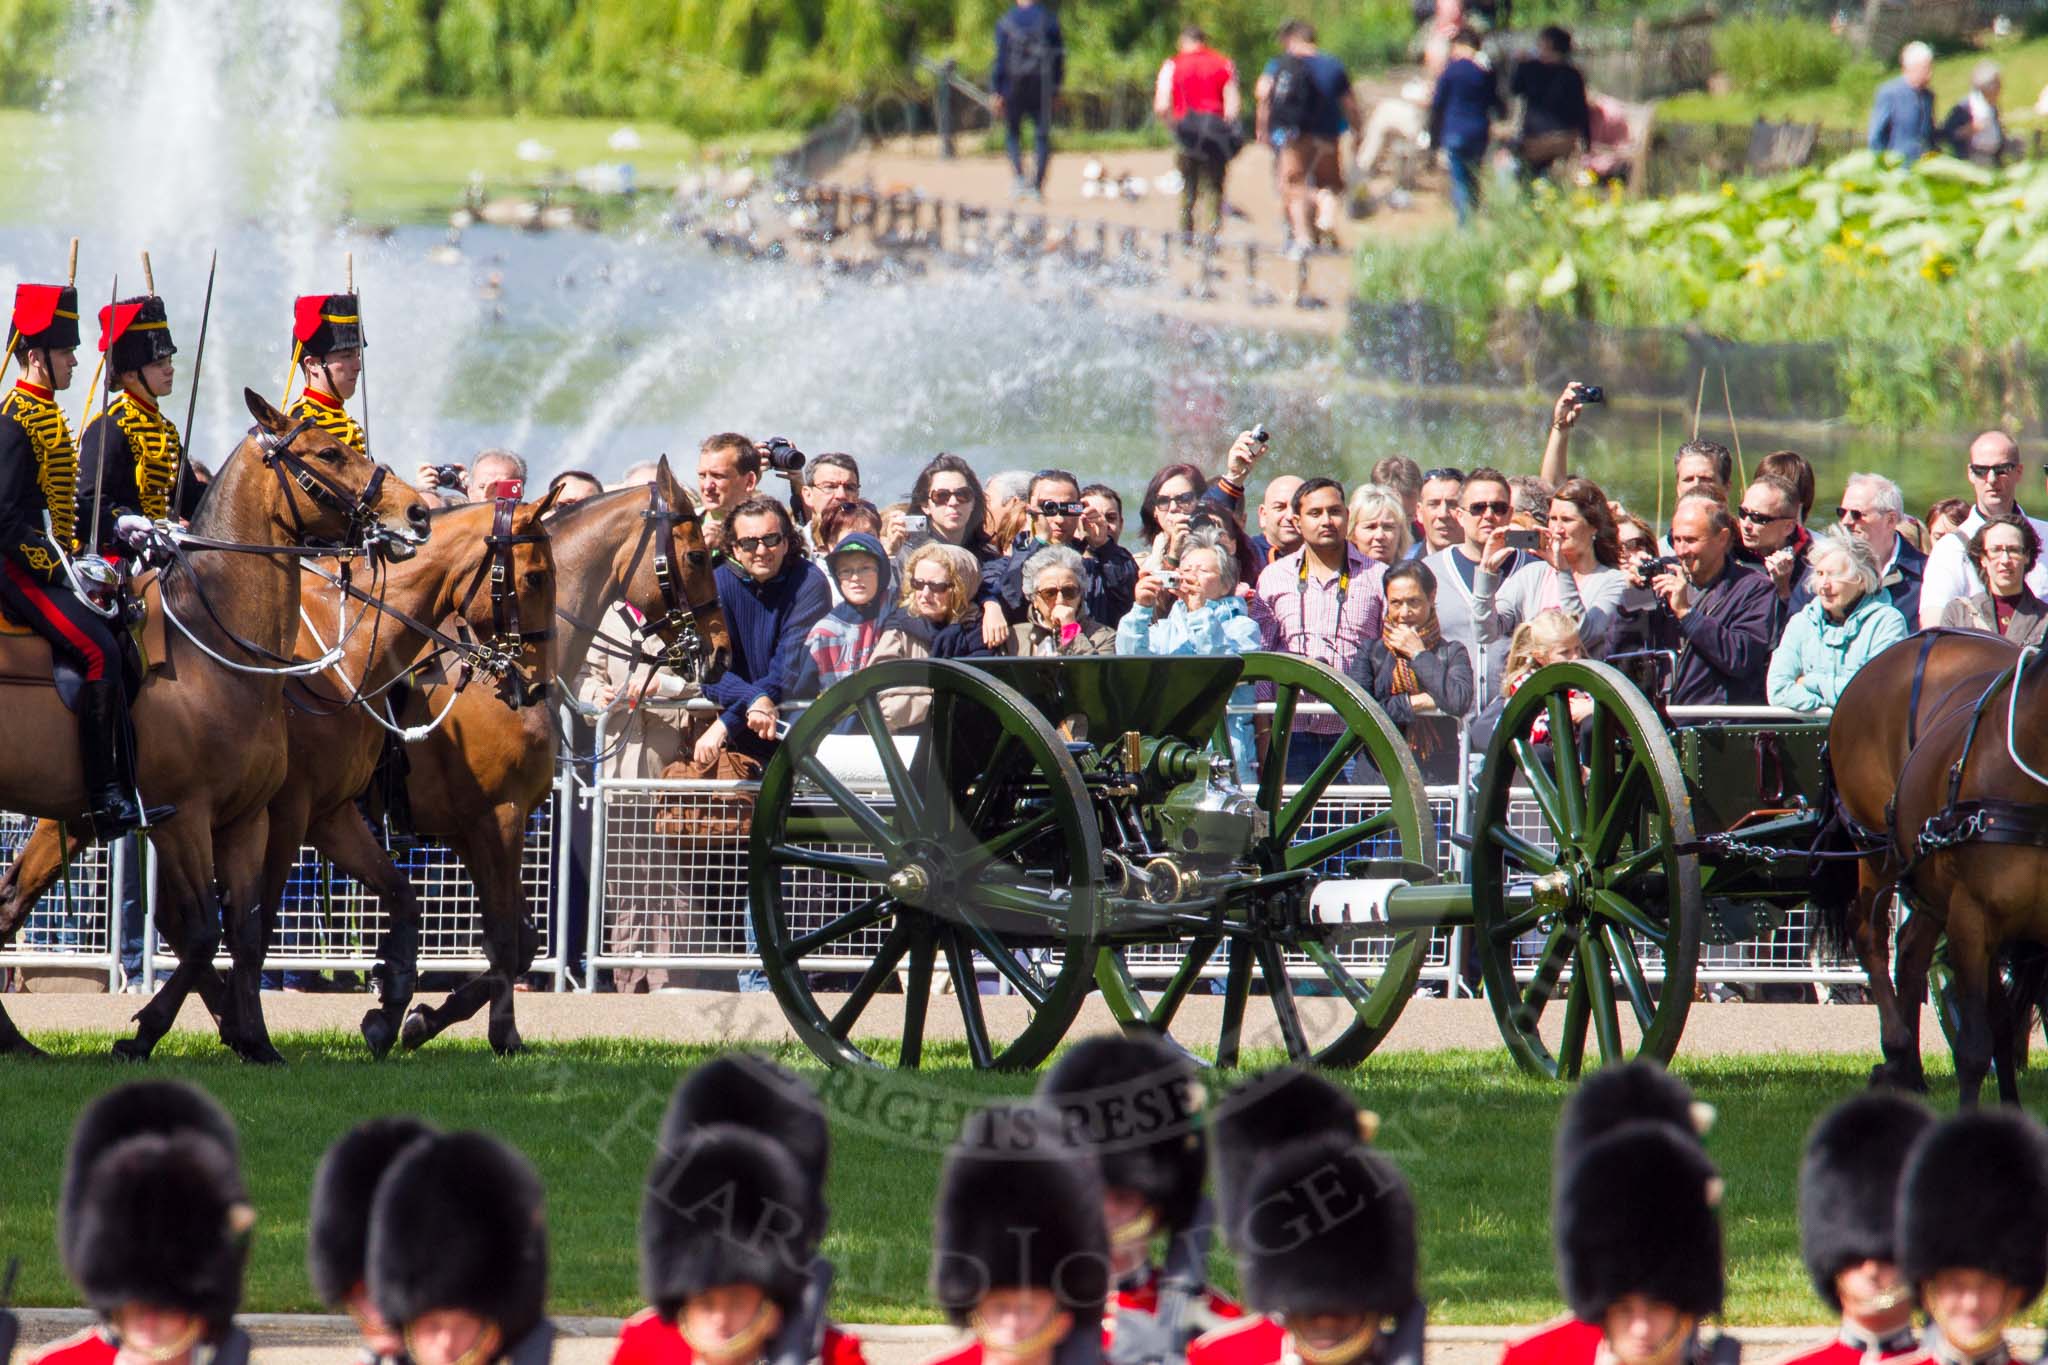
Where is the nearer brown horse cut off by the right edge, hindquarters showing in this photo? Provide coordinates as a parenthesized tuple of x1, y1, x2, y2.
(1890, 653, 2048, 1105)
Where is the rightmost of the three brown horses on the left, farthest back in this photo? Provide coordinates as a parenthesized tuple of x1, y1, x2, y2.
(401, 458, 731, 1052)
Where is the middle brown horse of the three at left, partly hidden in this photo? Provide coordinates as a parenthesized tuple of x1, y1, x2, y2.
(0, 495, 555, 1056)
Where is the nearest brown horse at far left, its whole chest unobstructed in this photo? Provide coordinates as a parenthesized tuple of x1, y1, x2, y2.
(0, 391, 426, 1060)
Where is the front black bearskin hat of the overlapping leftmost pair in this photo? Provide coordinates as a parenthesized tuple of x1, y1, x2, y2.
(61, 1128, 256, 1340)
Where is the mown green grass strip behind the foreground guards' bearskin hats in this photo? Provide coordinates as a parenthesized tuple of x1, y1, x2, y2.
(0, 1033, 2015, 1324)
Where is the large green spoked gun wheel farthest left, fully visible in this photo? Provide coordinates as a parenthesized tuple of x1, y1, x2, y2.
(748, 661, 1102, 1068)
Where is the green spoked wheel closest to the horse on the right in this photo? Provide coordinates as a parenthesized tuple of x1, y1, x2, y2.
(1470, 661, 1704, 1081)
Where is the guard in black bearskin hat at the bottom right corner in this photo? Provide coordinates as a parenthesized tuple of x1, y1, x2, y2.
(1898, 1109, 2048, 1365)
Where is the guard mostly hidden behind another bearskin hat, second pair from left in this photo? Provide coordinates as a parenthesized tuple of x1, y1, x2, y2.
(305, 1113, 434, 1365)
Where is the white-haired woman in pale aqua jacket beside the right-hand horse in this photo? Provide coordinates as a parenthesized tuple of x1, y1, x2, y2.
(1767, 526, 1909, 710)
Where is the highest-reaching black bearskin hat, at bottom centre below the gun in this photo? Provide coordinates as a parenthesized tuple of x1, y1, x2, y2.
(1038, 1031, 1208, 1234)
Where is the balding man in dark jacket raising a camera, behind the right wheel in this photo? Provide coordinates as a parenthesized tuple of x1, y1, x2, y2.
(1640, 493, 1778, 706)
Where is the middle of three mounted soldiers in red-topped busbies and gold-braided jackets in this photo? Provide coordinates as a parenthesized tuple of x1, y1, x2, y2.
(78, 295, 201, 548)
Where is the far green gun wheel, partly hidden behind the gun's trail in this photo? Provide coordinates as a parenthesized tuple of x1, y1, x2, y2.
(1096, 653, 1436, 1066)
